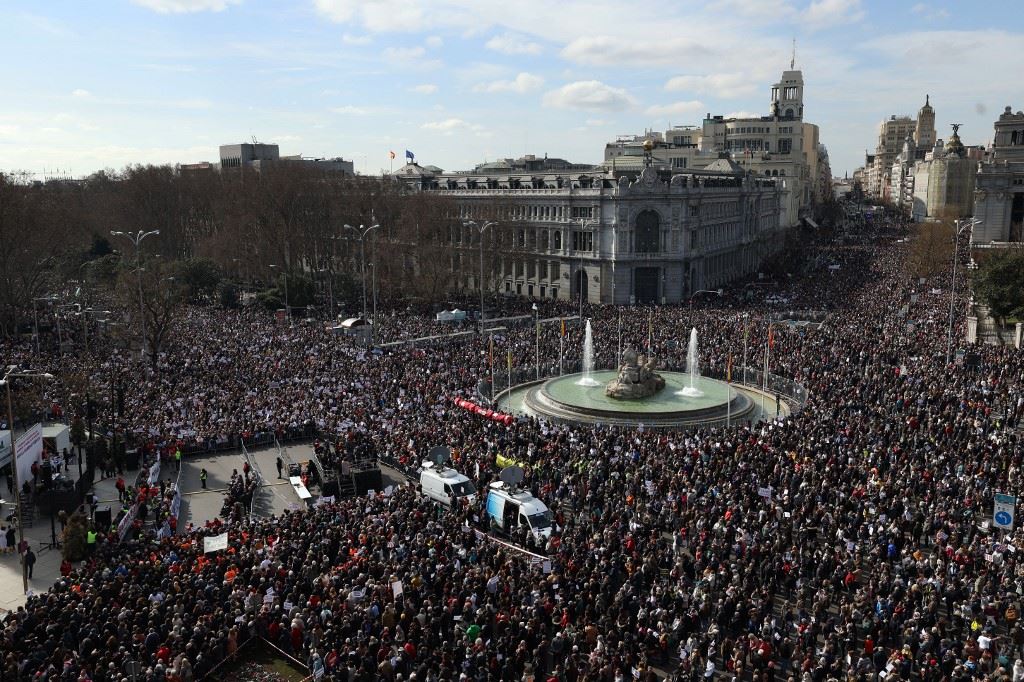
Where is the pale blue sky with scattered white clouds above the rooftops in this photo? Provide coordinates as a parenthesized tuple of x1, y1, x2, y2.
(0, 0, 1024, 178)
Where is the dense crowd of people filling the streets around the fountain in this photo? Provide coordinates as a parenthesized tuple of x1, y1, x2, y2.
(6, 210, 1024, 682)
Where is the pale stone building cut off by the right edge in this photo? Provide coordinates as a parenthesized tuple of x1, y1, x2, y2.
(971, 106, 1024, 245)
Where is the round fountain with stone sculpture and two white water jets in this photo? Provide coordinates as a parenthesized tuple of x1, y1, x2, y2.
(498, 321, 775, 428)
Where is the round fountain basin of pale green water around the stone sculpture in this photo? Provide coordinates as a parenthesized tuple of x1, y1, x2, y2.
(499, 371, 755, 428)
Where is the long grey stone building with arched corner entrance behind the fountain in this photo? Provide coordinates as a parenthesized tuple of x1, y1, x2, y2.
(394, 155, 785, 304)
